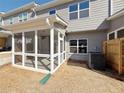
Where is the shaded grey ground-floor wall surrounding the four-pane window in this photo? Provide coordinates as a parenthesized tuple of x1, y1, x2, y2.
(66, 31, 107, 61)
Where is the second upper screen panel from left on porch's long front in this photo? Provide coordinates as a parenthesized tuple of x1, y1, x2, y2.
(24, 31, 35, 53)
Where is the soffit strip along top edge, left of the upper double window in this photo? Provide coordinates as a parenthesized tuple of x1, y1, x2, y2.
(35, 0, 74, 11)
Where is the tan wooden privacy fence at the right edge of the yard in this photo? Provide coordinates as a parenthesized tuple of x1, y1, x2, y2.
(103, 38, 124, 74)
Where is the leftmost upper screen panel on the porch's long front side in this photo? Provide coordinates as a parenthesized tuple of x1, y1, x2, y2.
(14, 33, 22, 52)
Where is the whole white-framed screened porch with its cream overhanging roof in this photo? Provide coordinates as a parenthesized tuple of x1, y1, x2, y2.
(6, 16, 67, 73)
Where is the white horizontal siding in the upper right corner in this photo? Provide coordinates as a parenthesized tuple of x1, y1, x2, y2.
(112, 0, 124, 14)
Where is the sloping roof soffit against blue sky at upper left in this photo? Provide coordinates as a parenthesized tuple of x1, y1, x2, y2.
(2, 2, 38, 17)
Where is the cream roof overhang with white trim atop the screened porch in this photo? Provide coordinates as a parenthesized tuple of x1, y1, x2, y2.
(0, 15, 67, 31)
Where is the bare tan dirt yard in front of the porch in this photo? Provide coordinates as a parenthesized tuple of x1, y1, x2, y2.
(0, 62, 124, 93)
